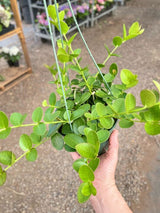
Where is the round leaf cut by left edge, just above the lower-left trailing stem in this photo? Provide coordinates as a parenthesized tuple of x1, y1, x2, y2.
(0, 151, 16, 166)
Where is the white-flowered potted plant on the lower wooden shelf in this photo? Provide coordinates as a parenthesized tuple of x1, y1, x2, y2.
(0, 46, 21, 67)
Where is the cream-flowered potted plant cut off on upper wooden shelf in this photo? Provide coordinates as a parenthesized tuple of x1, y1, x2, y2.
(0, 5, 14, 35)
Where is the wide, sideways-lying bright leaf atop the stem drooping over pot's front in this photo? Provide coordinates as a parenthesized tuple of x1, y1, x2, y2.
(75, 143, 97, 159)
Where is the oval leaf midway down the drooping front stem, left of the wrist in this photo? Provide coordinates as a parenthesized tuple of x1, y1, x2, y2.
(78, 165, 94, 182)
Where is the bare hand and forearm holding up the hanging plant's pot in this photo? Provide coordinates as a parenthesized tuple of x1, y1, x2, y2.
(71, 130, 132, 213)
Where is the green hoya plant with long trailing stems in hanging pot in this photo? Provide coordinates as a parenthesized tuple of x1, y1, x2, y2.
(0, 5, 160, 203)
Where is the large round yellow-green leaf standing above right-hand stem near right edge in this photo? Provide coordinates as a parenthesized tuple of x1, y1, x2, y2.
(140, 89, 156, 107)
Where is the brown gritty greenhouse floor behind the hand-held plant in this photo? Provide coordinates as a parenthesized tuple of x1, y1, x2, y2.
(0, 0, 160, 213)
